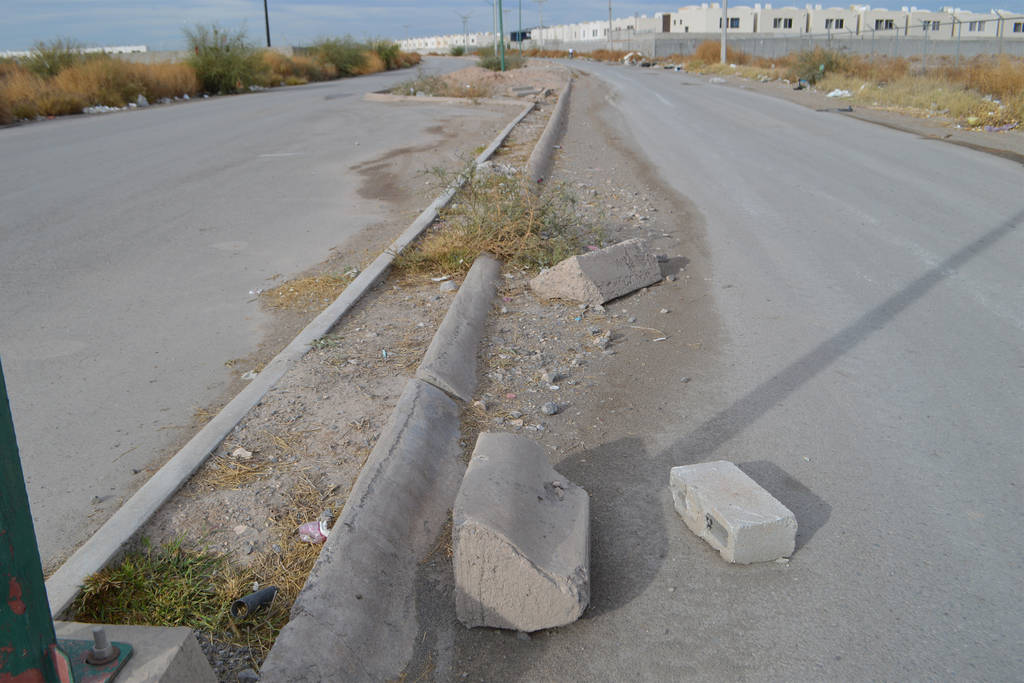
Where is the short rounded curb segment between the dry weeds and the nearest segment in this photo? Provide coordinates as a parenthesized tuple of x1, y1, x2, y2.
(416, 254, 502, 402)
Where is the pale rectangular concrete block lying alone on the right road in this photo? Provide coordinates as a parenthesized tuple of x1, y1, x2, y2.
(669, 460, 797, 564)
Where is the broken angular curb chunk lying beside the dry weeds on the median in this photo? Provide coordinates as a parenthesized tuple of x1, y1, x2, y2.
(529, 239, 662, 305)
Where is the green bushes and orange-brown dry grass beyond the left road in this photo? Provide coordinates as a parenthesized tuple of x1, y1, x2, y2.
(0, 26, 420, 125)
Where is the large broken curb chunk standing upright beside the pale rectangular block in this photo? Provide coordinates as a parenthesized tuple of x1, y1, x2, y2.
(452, 433, 590, 632)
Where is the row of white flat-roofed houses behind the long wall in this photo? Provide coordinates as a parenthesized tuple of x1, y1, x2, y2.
(400, 2, 1024, 52)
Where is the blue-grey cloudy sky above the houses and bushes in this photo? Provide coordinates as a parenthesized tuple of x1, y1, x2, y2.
(0, 0, 1024, 50)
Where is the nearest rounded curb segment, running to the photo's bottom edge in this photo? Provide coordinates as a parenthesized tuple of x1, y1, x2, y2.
(260, 380, 465, 682)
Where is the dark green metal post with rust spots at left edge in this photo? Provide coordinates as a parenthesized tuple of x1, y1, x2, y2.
(0, 358, 59, 681)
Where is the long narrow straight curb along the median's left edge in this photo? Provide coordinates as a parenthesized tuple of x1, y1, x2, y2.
(46, 102, 534, 617)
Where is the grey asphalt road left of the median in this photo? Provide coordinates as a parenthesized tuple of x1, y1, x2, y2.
(0, 59, 512, 568)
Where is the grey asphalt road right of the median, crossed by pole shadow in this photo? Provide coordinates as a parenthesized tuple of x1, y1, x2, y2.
(451, 62, 1024, 681)
